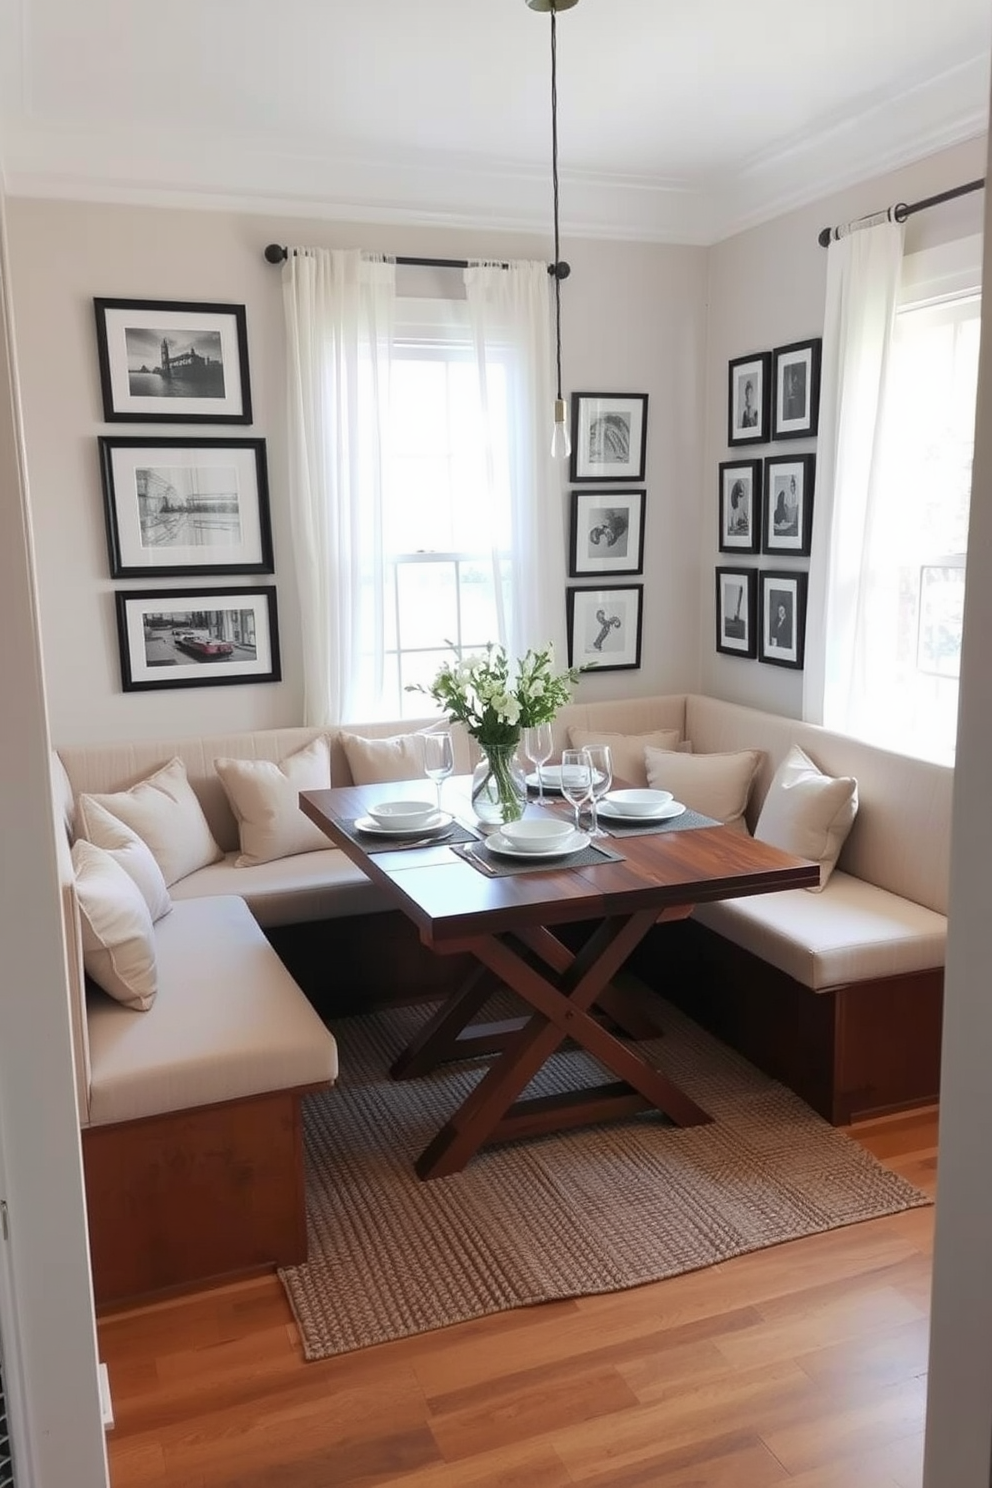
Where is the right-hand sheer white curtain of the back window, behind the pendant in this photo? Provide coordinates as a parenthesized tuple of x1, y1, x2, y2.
(466, 262, 567, 667)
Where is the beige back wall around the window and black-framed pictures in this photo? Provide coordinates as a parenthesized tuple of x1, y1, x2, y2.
(9, 199, 705, 744)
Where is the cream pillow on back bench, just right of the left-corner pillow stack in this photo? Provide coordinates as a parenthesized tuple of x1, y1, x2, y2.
(214, 734, 332, 868)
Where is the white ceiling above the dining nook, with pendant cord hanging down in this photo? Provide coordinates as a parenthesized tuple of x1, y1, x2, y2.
(0, 0, 992, 243)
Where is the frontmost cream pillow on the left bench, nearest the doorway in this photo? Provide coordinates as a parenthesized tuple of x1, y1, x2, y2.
(73, 838, 158, 1013)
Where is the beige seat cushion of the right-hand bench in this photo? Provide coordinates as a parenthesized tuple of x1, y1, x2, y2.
(693, 872, 947, 992)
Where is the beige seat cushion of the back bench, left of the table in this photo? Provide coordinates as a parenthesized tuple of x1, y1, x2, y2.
(171, 847, 391, 929)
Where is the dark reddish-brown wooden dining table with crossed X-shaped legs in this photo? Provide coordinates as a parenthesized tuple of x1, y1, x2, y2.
(299, 778, 819, 1178)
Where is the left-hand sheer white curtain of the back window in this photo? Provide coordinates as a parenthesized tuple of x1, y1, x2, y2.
(283, 248, 396, 725)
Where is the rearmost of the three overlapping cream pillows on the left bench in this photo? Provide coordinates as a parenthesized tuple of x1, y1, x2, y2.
(76, 756, 223, 884)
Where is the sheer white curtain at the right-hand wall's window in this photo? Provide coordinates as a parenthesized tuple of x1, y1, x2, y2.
(803, 220, 903, 735)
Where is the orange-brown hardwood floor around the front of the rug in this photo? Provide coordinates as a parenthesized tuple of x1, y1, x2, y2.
(98, 1110, 937, 1488)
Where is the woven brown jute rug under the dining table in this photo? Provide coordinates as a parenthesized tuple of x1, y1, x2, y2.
(280, 1003, 930, 1360)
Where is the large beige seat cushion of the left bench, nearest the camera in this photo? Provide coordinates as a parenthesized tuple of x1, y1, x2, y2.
(88, 897, 338, 1126)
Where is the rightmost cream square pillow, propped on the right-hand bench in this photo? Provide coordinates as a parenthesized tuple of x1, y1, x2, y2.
(754, 744, 858, 894)
